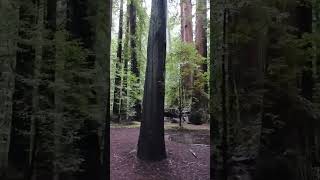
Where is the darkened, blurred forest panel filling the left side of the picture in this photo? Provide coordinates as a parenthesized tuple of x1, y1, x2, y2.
(0, 0, 112, 180)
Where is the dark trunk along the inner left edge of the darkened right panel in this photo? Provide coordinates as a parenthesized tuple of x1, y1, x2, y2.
(210, 0, 225, 180)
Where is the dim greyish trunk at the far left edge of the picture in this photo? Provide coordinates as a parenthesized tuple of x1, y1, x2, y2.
(0, 0, 18, 178)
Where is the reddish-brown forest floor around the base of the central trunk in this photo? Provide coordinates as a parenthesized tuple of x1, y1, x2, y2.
(110, 122, 210, 180)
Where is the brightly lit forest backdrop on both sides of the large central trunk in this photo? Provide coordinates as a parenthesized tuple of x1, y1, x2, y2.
(111, 0, 210, 124)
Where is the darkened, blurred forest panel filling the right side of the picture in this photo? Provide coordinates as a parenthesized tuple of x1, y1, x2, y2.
(210, 0, 320, 180)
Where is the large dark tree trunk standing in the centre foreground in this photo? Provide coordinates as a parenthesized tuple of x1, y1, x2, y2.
(137, 0, 167, 160)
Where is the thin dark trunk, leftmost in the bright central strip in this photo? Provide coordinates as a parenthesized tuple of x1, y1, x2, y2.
(112, 0, 123, 122)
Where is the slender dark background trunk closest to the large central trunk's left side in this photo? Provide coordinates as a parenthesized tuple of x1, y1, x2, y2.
(129, 0, 141, 121)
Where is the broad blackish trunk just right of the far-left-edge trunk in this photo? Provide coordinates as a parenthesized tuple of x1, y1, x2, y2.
(9, 1, 35, 176)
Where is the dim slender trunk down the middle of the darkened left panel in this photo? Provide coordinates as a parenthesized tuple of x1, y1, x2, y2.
(47, 0, 67, 180)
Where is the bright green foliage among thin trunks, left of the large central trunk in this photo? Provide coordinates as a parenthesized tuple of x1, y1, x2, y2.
(111, 0, 149, 117)
